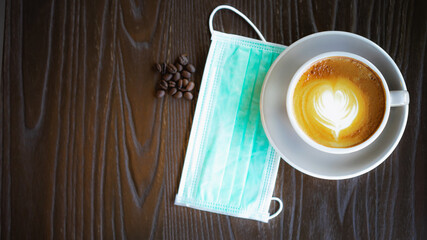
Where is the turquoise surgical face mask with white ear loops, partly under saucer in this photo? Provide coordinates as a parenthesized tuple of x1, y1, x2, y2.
(175, 6, 285, 222)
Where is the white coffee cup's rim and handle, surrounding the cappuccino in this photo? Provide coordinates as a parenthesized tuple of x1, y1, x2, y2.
(286, 52, 409, 154)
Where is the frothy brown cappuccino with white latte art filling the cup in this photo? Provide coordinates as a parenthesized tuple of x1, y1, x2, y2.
(293, 56, 386, 148)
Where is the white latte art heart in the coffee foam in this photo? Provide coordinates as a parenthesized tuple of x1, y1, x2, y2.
(313, 88, 359, 139)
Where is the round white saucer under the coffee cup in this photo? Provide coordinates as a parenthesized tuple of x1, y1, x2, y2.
(260, 31, 409, 179)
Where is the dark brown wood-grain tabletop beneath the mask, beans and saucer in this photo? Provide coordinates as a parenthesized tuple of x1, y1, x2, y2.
(0, 0, 427, 239)
